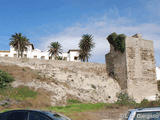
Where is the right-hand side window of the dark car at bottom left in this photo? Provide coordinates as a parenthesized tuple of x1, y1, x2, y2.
(29, 112, 51, 120)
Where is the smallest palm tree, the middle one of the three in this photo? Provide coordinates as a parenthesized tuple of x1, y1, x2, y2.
(49, 42, 62, 59)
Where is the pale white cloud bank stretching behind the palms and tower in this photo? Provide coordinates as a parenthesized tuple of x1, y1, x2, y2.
(39, 15, 160, 63)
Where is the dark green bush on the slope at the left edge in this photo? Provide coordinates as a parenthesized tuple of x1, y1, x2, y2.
(0, 70, 14, 88)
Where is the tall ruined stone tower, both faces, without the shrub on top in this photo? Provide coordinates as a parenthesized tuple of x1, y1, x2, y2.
(106, 34, 158, 102)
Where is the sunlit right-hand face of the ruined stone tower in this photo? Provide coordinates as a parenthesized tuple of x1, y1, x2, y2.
(126, 37, 158, 102)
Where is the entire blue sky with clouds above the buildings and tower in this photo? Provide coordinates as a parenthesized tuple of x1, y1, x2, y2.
(0, 0, 160, 66)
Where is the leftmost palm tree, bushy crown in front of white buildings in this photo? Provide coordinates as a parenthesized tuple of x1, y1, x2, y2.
(10, 33, 29, 58)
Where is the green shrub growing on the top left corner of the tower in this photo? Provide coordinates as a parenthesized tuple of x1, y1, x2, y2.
(107, 32, 126, 53)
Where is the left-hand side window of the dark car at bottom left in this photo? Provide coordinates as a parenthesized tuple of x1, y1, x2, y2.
(7, 112, 28, 120)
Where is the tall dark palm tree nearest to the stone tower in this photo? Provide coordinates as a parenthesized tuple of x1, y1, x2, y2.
(79, 34, 95, 62)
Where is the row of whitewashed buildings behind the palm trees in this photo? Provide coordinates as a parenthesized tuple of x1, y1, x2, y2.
(0, 44, 80, 61)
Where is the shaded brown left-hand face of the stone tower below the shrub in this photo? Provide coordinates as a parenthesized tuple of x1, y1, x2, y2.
(106, 45, 127, 90)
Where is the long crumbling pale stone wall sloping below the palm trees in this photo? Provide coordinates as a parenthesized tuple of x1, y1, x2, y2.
(0, 57, 121, 105)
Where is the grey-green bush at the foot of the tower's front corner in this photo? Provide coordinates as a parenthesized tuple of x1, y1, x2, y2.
(116, 93, 136, 105)
